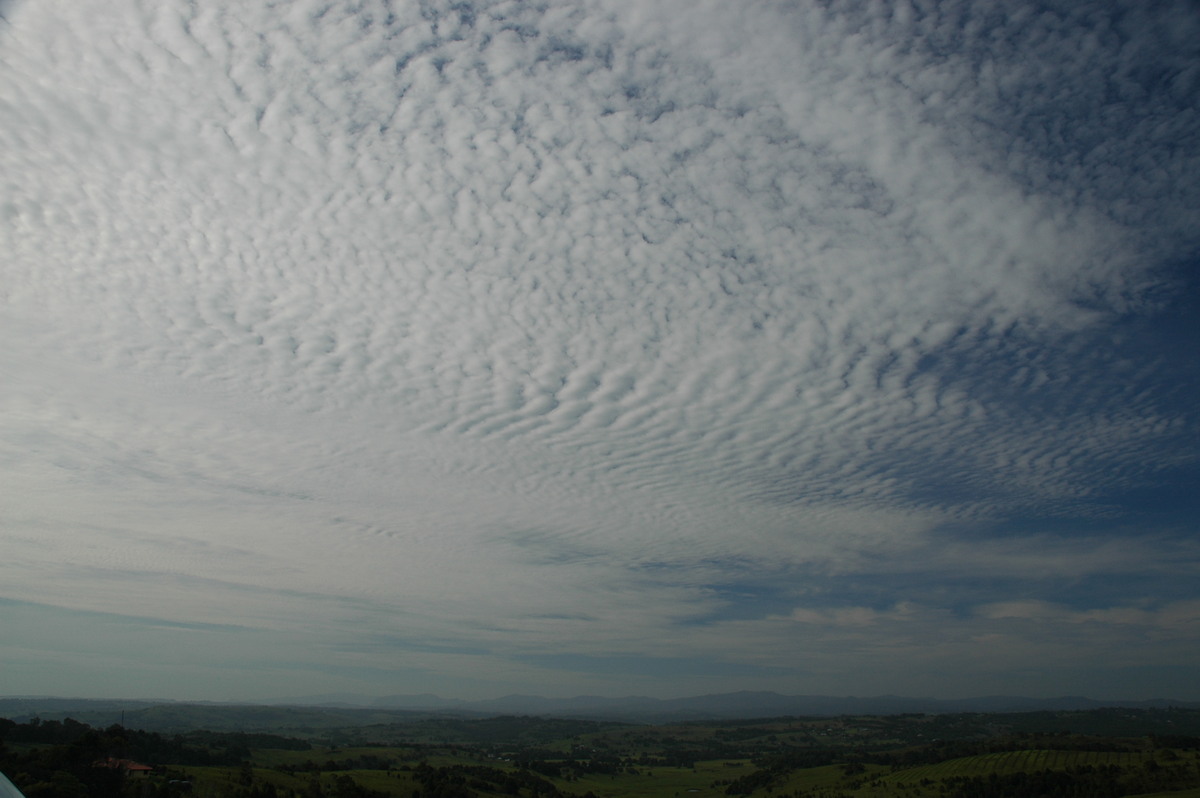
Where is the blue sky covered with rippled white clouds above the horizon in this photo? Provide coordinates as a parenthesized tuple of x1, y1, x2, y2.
(0, 0, 1200, 701)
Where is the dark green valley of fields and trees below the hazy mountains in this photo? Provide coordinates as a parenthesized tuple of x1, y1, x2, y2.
(0, 709, 1200, 798)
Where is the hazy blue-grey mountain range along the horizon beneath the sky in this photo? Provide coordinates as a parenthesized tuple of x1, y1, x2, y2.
(0, 691, 1200, 730)
